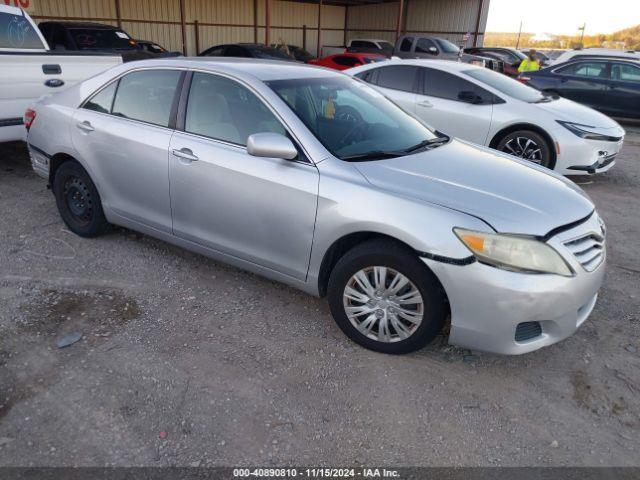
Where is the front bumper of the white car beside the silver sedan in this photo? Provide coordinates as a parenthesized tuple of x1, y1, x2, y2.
(554, 129, 624, 175)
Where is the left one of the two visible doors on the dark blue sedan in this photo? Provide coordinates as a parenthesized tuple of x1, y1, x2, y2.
(555, 60, 611, 111)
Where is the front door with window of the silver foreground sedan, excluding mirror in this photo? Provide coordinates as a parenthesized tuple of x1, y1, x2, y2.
(169, 72, 319, 280)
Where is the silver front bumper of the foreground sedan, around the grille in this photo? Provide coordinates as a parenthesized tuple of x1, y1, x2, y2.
(422, 214, 606, 355)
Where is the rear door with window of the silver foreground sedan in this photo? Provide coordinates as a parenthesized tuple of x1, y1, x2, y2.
(71, 69, 184, 233)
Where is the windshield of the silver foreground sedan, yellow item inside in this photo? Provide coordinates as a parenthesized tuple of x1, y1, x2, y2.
(267, 77, 443, 161)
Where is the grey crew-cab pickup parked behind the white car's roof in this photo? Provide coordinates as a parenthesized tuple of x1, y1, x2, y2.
(393, 35, 504, 72)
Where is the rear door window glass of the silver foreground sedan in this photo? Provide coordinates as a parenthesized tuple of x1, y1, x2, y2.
(113, 70, 182, 127)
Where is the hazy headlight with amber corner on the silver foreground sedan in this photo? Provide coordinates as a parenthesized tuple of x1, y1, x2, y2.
(453, 228, 573, 277)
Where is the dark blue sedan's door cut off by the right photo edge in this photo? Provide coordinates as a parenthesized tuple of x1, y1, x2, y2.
(606, 62, 640, 118)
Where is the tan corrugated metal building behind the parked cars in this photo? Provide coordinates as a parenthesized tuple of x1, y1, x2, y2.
(17, 0, 489, 55)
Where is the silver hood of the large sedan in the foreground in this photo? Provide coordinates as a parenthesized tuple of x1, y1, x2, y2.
(354, 140, 594, 236)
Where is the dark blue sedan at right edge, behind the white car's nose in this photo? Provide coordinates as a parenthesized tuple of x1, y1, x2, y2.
(518, 57, 640, 118)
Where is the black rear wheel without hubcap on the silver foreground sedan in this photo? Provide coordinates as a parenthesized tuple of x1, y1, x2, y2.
(53, 160, 109, 238)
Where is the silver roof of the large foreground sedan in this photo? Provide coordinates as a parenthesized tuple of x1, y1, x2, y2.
(121, 57, 344, 82)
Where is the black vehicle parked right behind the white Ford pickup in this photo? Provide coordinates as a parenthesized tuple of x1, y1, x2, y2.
(38, 22, 158, 62)
